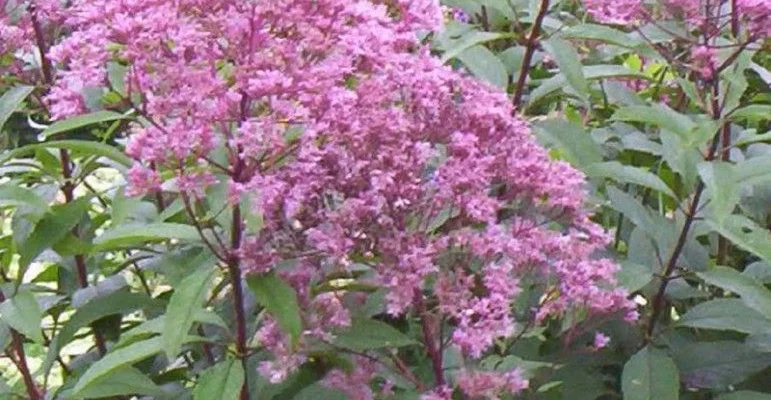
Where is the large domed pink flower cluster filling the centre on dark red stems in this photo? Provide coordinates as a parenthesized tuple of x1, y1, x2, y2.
(40, 0, 634, 399)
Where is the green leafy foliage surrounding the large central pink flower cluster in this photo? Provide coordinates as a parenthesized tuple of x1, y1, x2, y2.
(0, 0, 771, 400)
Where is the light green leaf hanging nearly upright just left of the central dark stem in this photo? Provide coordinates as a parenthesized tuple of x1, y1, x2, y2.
(161, 268, 214, 360)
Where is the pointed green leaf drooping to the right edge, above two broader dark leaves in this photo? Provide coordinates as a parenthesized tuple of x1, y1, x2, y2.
(697, 266, 771, 319)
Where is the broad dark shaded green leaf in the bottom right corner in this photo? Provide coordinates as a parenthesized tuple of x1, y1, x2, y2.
(672, 341, 771, 389)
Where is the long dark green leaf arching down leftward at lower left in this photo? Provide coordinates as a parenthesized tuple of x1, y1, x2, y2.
(41, 290, 157, 374)
